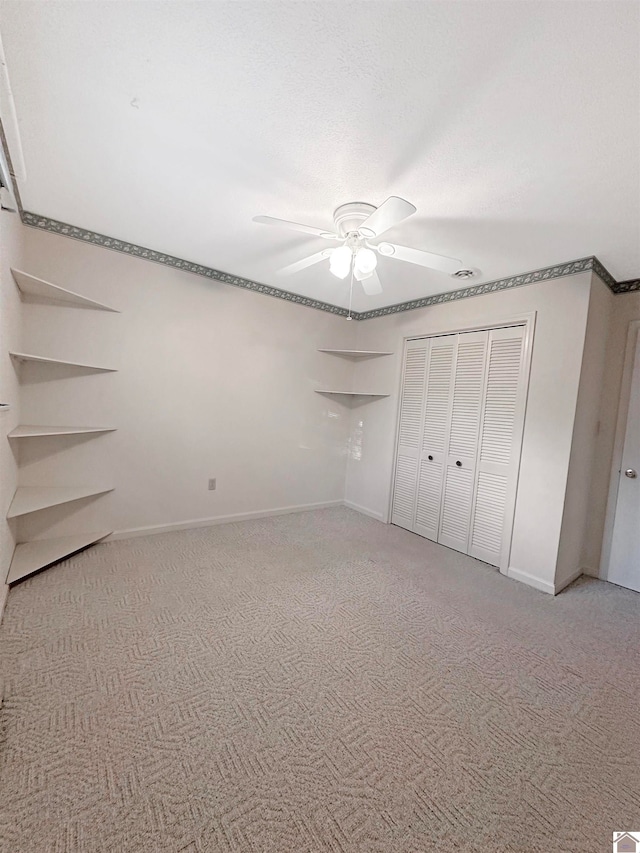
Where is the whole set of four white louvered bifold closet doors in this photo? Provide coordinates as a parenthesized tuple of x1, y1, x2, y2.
(391, 325, 526, 566)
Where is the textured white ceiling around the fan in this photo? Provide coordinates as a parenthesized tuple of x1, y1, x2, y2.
(0, 0, 640, 310)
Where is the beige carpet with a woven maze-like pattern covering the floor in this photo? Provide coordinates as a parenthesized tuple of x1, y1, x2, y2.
(0, 509, 640, 853)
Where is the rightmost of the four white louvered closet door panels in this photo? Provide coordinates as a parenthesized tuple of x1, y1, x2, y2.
(468, 326, 525, 566)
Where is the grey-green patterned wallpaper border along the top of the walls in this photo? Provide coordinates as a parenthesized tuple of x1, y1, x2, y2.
(20, 210, 640, 320)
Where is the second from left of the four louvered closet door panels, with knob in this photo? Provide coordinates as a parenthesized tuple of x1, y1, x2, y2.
(414, 335, 458, 542)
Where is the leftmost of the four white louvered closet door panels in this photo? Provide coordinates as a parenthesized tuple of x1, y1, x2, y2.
(391, 340, 429, 530)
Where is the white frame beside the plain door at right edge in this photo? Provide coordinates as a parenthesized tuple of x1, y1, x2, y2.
(598, 320, 640, 581)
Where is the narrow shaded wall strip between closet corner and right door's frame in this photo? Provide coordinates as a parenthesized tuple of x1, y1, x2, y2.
(584, 292, 640, 580)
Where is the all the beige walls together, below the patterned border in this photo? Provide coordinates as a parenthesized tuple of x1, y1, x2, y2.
(2, 215, 640, 591)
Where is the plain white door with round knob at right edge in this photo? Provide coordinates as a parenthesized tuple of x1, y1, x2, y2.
(607, 334, 640, 592)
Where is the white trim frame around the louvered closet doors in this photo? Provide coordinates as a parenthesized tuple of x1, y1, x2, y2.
(385, 311, 537, 575)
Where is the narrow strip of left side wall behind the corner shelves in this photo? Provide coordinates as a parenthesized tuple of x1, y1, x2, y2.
(0, 211, 26, 618)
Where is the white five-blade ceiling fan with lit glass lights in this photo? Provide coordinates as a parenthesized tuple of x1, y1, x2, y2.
(253, 195, 473, 296)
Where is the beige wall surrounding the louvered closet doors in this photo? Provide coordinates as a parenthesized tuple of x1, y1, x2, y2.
(346, 273, 591, 592)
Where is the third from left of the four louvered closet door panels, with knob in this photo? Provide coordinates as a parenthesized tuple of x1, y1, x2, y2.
(438, 332, 489, 554)
